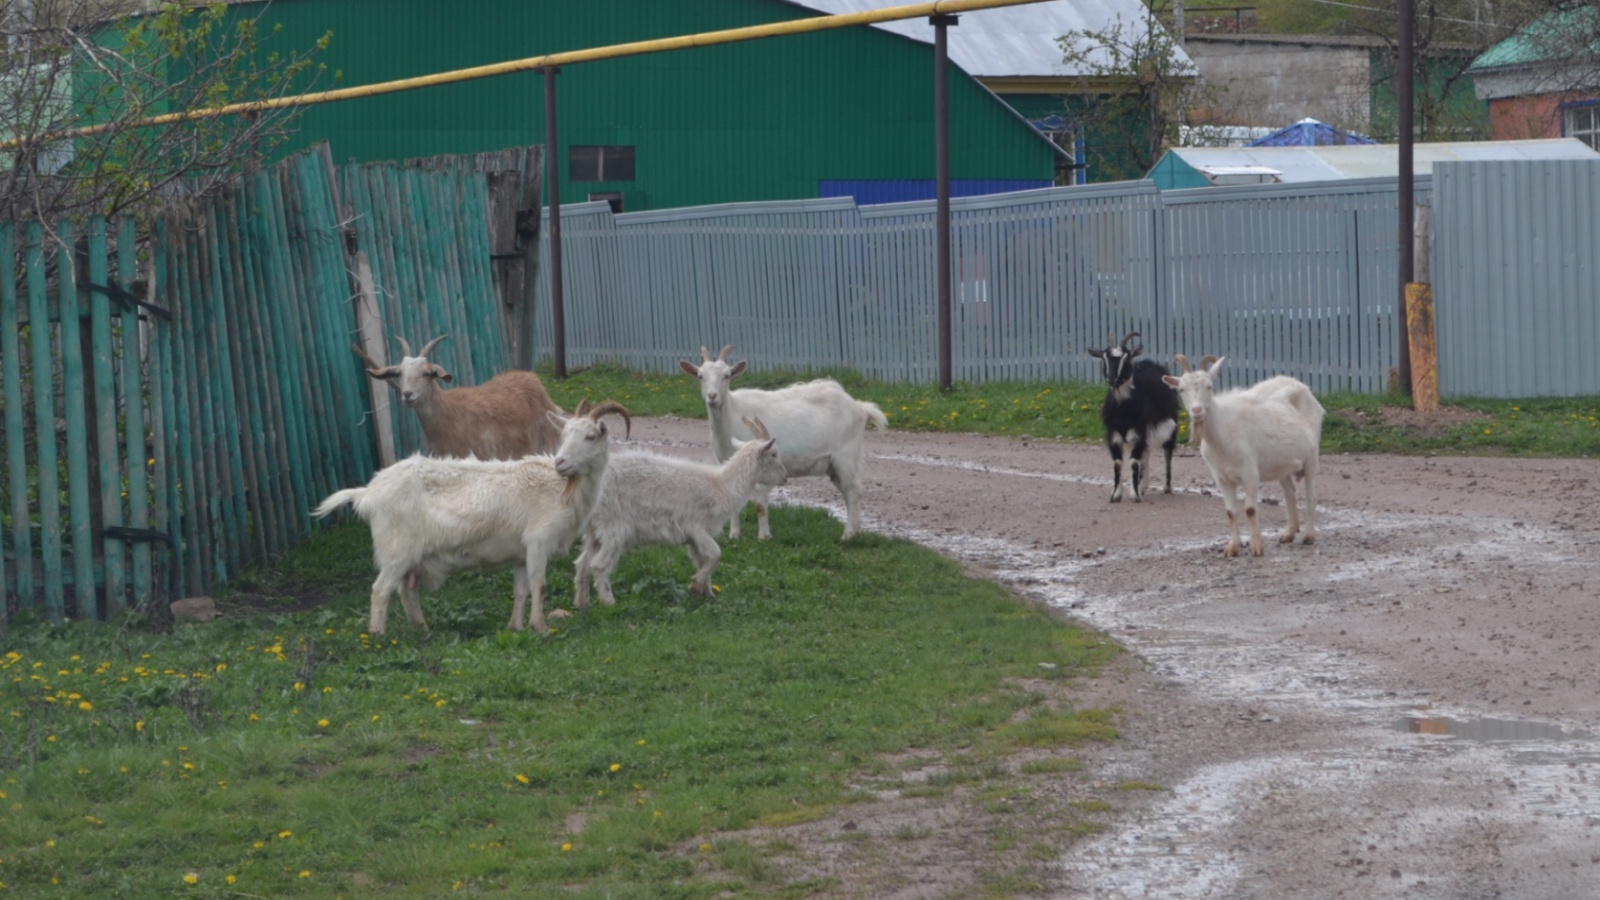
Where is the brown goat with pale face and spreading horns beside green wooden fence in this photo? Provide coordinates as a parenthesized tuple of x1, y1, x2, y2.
(350, 335, 562, 460)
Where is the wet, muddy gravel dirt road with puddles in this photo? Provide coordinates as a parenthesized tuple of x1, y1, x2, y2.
(635, 418, 1600, 900)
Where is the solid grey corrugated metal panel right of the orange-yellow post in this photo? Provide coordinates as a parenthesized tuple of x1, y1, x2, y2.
(1432, 160, 1600, 397)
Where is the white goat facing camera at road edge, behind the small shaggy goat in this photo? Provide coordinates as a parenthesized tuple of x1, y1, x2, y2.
(678, 344, 890, 540)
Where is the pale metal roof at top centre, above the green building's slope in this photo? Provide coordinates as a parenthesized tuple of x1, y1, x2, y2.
(797, 0, 1194, 78)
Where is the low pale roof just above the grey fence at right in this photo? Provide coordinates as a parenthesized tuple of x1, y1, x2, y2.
(1157, 138, 1600, 183)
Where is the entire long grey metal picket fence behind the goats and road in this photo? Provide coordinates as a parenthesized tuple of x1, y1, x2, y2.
(536, 179, 1398, 391)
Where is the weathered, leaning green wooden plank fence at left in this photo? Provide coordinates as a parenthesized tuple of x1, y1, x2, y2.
(0, 146, 538, 629)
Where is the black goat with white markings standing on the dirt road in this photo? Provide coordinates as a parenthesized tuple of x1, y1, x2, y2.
(1088, 331, 1178, 503)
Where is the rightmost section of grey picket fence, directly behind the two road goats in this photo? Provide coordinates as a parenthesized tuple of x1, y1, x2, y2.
(1162, 179, 1426, 392)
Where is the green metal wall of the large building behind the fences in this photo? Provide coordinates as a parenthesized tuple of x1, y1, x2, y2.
(238, 0, 1054, 210)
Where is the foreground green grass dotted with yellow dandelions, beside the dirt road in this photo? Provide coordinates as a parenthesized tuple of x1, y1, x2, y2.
(0, 508, 1120, 897)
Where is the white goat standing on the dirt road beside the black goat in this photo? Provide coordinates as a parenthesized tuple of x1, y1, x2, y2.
(1163, 354, 1323, 557)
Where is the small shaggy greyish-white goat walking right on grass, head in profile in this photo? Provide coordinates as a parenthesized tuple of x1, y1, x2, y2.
(573, 420, 787, 609)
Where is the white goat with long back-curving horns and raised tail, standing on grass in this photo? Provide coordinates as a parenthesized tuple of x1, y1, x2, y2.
(312, 400, 632, 634)
